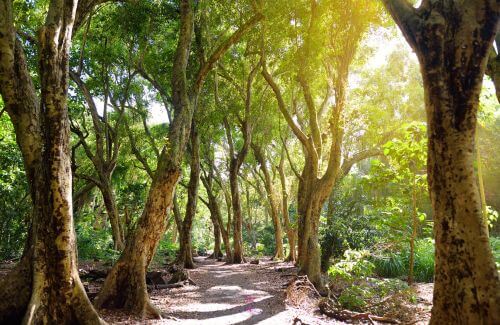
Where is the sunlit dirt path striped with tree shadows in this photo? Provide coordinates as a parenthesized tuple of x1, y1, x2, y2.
(145, 257, 332, 325)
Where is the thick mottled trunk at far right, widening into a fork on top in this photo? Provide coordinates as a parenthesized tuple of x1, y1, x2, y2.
(384, 0, 500, 324)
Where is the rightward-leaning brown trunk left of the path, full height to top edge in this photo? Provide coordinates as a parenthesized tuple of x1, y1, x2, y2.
(95, 0, 193, 317)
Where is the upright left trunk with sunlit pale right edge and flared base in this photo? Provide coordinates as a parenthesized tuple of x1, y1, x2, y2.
(27, 2, 101, 324)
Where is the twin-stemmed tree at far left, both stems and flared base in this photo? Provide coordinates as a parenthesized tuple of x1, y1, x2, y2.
(0, 1, 102, 324)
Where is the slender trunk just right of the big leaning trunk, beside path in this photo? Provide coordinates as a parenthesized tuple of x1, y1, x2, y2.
(178, 122, 200, 269)
